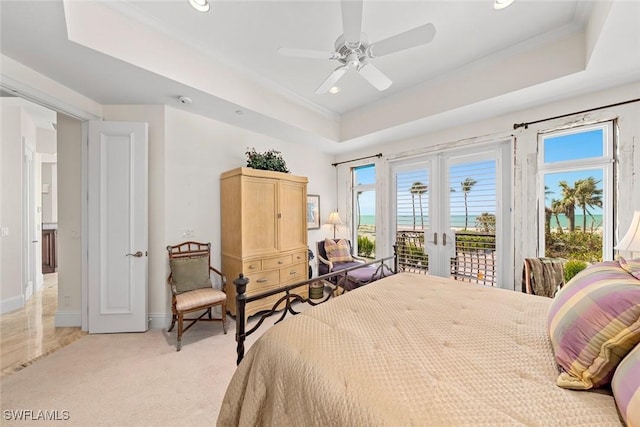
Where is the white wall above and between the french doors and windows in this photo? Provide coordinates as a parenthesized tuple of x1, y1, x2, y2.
(337, 83, 640, 288)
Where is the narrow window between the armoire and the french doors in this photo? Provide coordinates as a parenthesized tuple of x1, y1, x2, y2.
(352, 165, 376, 259)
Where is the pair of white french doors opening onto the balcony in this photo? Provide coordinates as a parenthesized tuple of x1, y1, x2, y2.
(392, 143, 513, 288)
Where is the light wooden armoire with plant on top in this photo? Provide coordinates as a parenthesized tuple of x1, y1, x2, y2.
(220, 168, 308, 317)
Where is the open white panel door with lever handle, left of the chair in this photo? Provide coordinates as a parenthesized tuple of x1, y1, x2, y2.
(87, 121, 148, 333)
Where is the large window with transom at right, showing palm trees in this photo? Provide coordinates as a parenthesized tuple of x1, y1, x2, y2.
(539, 122, 614, 262)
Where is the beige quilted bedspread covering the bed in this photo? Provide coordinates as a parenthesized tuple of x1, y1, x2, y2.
(218, 274, 621, 427)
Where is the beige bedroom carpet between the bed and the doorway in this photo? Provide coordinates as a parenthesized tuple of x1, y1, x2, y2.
(0, 318, 276, 426)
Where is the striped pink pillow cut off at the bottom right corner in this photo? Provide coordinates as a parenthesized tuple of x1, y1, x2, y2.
(611, 345, 640, 427)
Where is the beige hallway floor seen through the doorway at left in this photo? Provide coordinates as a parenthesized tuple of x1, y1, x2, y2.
(0, 273, 86, 377)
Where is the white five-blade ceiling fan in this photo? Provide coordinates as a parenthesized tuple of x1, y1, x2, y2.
(278, 0, 436, 94)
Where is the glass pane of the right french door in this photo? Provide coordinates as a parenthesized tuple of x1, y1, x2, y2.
(449, 160, 497, 286)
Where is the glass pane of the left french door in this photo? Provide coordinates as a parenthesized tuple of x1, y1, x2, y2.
(396, 169, 429, 274)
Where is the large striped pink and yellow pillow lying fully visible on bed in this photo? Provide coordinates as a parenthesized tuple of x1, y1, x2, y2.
(548, 261, 640, 390)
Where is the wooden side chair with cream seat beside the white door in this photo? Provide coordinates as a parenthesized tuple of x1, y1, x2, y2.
(167, 242, 227, 351)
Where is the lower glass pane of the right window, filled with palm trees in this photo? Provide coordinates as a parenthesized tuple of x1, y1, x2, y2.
(544, 168, 604, 262)
